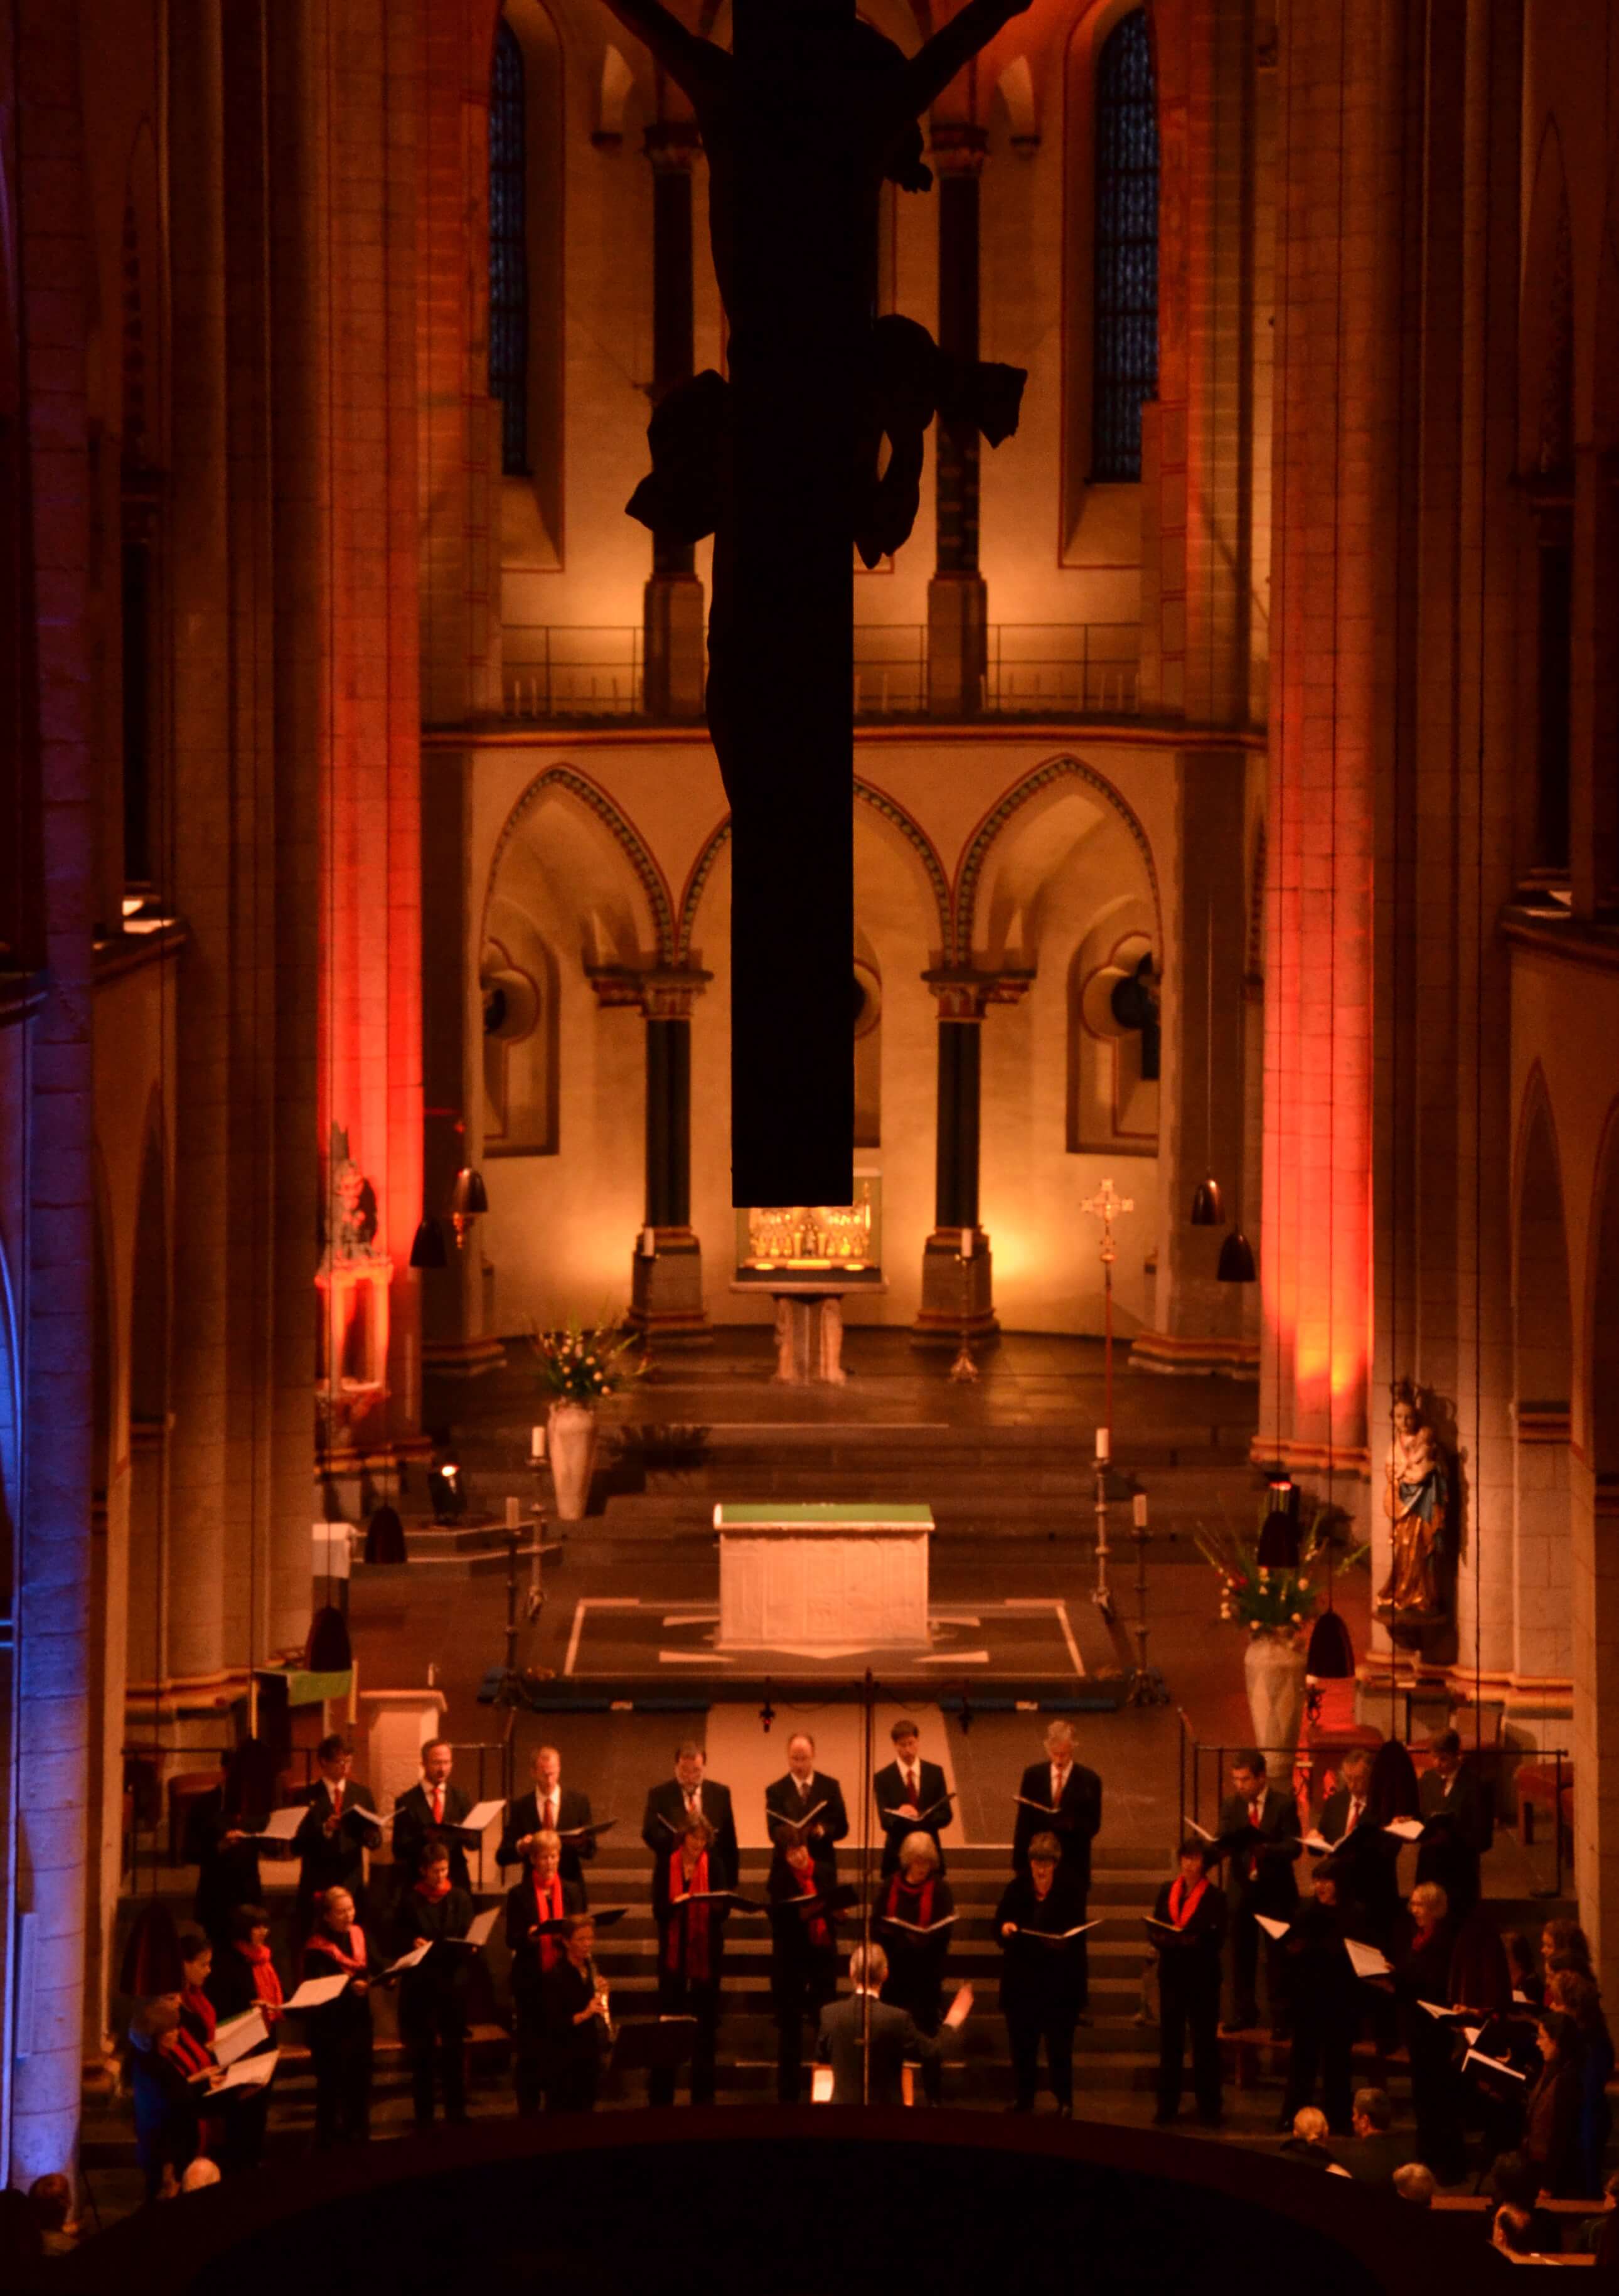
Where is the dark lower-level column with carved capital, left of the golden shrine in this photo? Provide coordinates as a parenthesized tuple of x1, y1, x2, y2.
(611, 971, 712, 1348)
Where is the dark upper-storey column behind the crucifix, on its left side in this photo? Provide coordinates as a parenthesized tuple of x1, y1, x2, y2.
(641, 119, 705, 718)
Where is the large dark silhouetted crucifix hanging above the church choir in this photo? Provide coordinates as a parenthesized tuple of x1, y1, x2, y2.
(606, 0, 1029, 1205)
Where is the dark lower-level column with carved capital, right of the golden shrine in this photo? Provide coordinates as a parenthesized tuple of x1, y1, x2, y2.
(912, 969, 1029, 1348)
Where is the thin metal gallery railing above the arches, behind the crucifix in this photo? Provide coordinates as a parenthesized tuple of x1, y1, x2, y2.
(503, 622, 1141, 724)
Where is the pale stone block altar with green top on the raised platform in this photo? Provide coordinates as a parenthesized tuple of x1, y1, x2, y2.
(714, 1502, 932, 1658)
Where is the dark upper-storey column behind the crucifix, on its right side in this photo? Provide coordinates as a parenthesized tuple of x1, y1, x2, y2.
(927, 119, 990, 718)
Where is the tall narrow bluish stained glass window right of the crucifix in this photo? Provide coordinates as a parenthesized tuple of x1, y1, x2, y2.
(1091, 7, 1157, 480)
